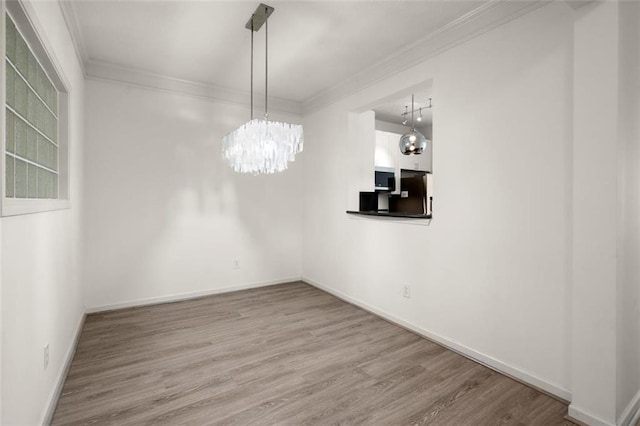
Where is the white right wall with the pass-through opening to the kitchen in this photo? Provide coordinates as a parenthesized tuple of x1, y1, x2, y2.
(303, 3, 573, 398)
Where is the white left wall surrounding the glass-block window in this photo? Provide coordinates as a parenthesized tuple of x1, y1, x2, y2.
(0, 2, 84, 425)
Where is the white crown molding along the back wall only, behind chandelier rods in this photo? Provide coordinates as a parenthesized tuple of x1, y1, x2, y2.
(85, 59, 302, 115)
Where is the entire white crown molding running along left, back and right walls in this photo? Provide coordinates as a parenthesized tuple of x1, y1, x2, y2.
(58, 0, 544, 115)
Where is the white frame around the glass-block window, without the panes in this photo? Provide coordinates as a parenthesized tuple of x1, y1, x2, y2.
(0, 0, 71, 216)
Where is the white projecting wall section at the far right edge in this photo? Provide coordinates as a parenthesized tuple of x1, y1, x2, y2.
(569, 2, 640, 425)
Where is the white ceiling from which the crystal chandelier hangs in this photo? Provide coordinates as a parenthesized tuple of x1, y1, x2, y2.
(63, 0, 544, 114)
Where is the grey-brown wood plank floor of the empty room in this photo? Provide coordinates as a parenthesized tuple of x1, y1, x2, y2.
(53, 282, 572, 426)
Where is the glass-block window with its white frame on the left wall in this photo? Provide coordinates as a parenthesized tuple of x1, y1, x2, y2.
(2, 2, 69, 216)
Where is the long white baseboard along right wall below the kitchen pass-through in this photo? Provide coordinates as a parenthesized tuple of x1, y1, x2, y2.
(302, 277, 571, 403)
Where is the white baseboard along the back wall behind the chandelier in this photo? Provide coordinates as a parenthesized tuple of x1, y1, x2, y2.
(86, 276, 302, 314)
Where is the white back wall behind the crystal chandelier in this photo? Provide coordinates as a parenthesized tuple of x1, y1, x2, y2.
(84, 80, 306, 309)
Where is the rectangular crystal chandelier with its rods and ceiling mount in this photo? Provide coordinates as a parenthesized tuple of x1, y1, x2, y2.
(222, 3, 304, 175)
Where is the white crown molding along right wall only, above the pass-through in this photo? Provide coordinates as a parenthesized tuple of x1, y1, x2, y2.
(302, 0, 551, 113)
